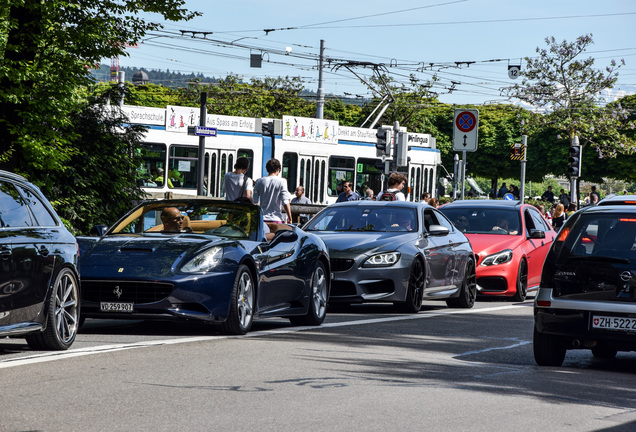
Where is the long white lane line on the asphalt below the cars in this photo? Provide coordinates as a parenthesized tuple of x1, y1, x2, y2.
(0, 303, 523, 369)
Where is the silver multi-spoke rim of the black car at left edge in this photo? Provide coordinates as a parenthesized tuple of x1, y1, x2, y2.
(55, 273, 79, 344)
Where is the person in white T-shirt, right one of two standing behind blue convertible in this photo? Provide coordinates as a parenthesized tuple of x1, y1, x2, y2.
(254, 158, 292, 223)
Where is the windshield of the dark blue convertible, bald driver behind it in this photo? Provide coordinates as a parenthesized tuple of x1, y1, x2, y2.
(109, 200, 260, 240)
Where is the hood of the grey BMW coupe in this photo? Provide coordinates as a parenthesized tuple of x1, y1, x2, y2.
(312, 231, 418, 258)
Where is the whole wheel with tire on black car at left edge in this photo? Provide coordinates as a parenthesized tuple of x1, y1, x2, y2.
(26, 268, 80, 351)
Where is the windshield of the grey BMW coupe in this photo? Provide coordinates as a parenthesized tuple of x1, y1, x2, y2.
(305, 205, 417, 232)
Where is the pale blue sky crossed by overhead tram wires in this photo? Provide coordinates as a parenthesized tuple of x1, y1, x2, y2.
(120, 0, 636, 105)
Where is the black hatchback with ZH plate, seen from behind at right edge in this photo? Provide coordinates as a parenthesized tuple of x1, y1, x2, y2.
(533, 195, 636, 366)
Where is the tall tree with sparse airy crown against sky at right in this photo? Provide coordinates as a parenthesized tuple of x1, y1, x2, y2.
(504, 35, 636, 175)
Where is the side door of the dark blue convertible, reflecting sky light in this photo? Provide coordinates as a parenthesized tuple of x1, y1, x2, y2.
(258, 229, 305, 313)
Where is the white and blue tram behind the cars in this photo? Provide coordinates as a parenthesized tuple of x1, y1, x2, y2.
(122, 105, 441, 204)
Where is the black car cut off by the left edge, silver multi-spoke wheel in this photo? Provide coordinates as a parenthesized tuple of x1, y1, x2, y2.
(0, 171, 80, 350)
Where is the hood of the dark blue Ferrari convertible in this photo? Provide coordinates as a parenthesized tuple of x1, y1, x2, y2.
(78, 234, 225, 276)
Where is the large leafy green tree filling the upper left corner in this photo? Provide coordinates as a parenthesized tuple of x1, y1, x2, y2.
(0, 0, 196, 184)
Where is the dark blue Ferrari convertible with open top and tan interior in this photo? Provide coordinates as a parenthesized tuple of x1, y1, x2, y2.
(78, 198, 331, 334)
